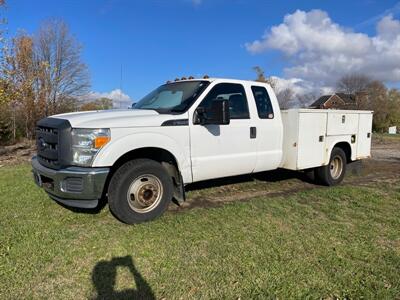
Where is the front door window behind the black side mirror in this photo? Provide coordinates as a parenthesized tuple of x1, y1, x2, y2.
(200, 83, 249, 119)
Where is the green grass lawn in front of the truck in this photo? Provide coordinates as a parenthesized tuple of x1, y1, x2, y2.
(0, 164, 400, 299)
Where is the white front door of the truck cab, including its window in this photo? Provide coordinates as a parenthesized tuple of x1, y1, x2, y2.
(190, 83, 257, 181)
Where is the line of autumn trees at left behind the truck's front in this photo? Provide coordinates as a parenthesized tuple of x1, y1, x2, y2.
(0, 0, 112, 144)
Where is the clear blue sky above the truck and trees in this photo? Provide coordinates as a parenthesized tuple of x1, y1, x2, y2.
(5, 0, 400, 103)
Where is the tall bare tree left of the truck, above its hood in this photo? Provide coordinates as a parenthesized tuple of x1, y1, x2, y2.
(35, 20, 90, 114)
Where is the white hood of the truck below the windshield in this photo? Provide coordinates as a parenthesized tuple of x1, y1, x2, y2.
(51, 109, 177, 128)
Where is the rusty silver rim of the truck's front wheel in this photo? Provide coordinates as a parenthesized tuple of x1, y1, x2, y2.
(126, 174, 163, 214)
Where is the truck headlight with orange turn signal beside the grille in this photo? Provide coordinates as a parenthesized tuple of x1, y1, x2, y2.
(72, 128, 111, 167)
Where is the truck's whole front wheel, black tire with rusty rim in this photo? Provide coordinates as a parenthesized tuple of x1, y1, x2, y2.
(108, 159, 173, 224)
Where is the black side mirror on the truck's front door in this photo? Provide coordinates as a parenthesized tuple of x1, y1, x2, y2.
(194, 99, 230, 125)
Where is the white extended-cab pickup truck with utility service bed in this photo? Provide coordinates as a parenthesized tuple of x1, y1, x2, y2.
(32, 78, 372, 224)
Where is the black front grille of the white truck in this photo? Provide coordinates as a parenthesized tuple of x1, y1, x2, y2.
(36, 118, 71, 169)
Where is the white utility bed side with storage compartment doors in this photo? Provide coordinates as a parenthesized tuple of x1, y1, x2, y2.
(280, 109, 372, 170)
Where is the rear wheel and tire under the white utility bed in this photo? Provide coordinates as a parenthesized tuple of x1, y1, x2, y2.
(315, 148, 347, 186)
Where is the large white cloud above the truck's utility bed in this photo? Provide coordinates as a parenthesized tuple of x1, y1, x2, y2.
(246, 10, 400, 94)
